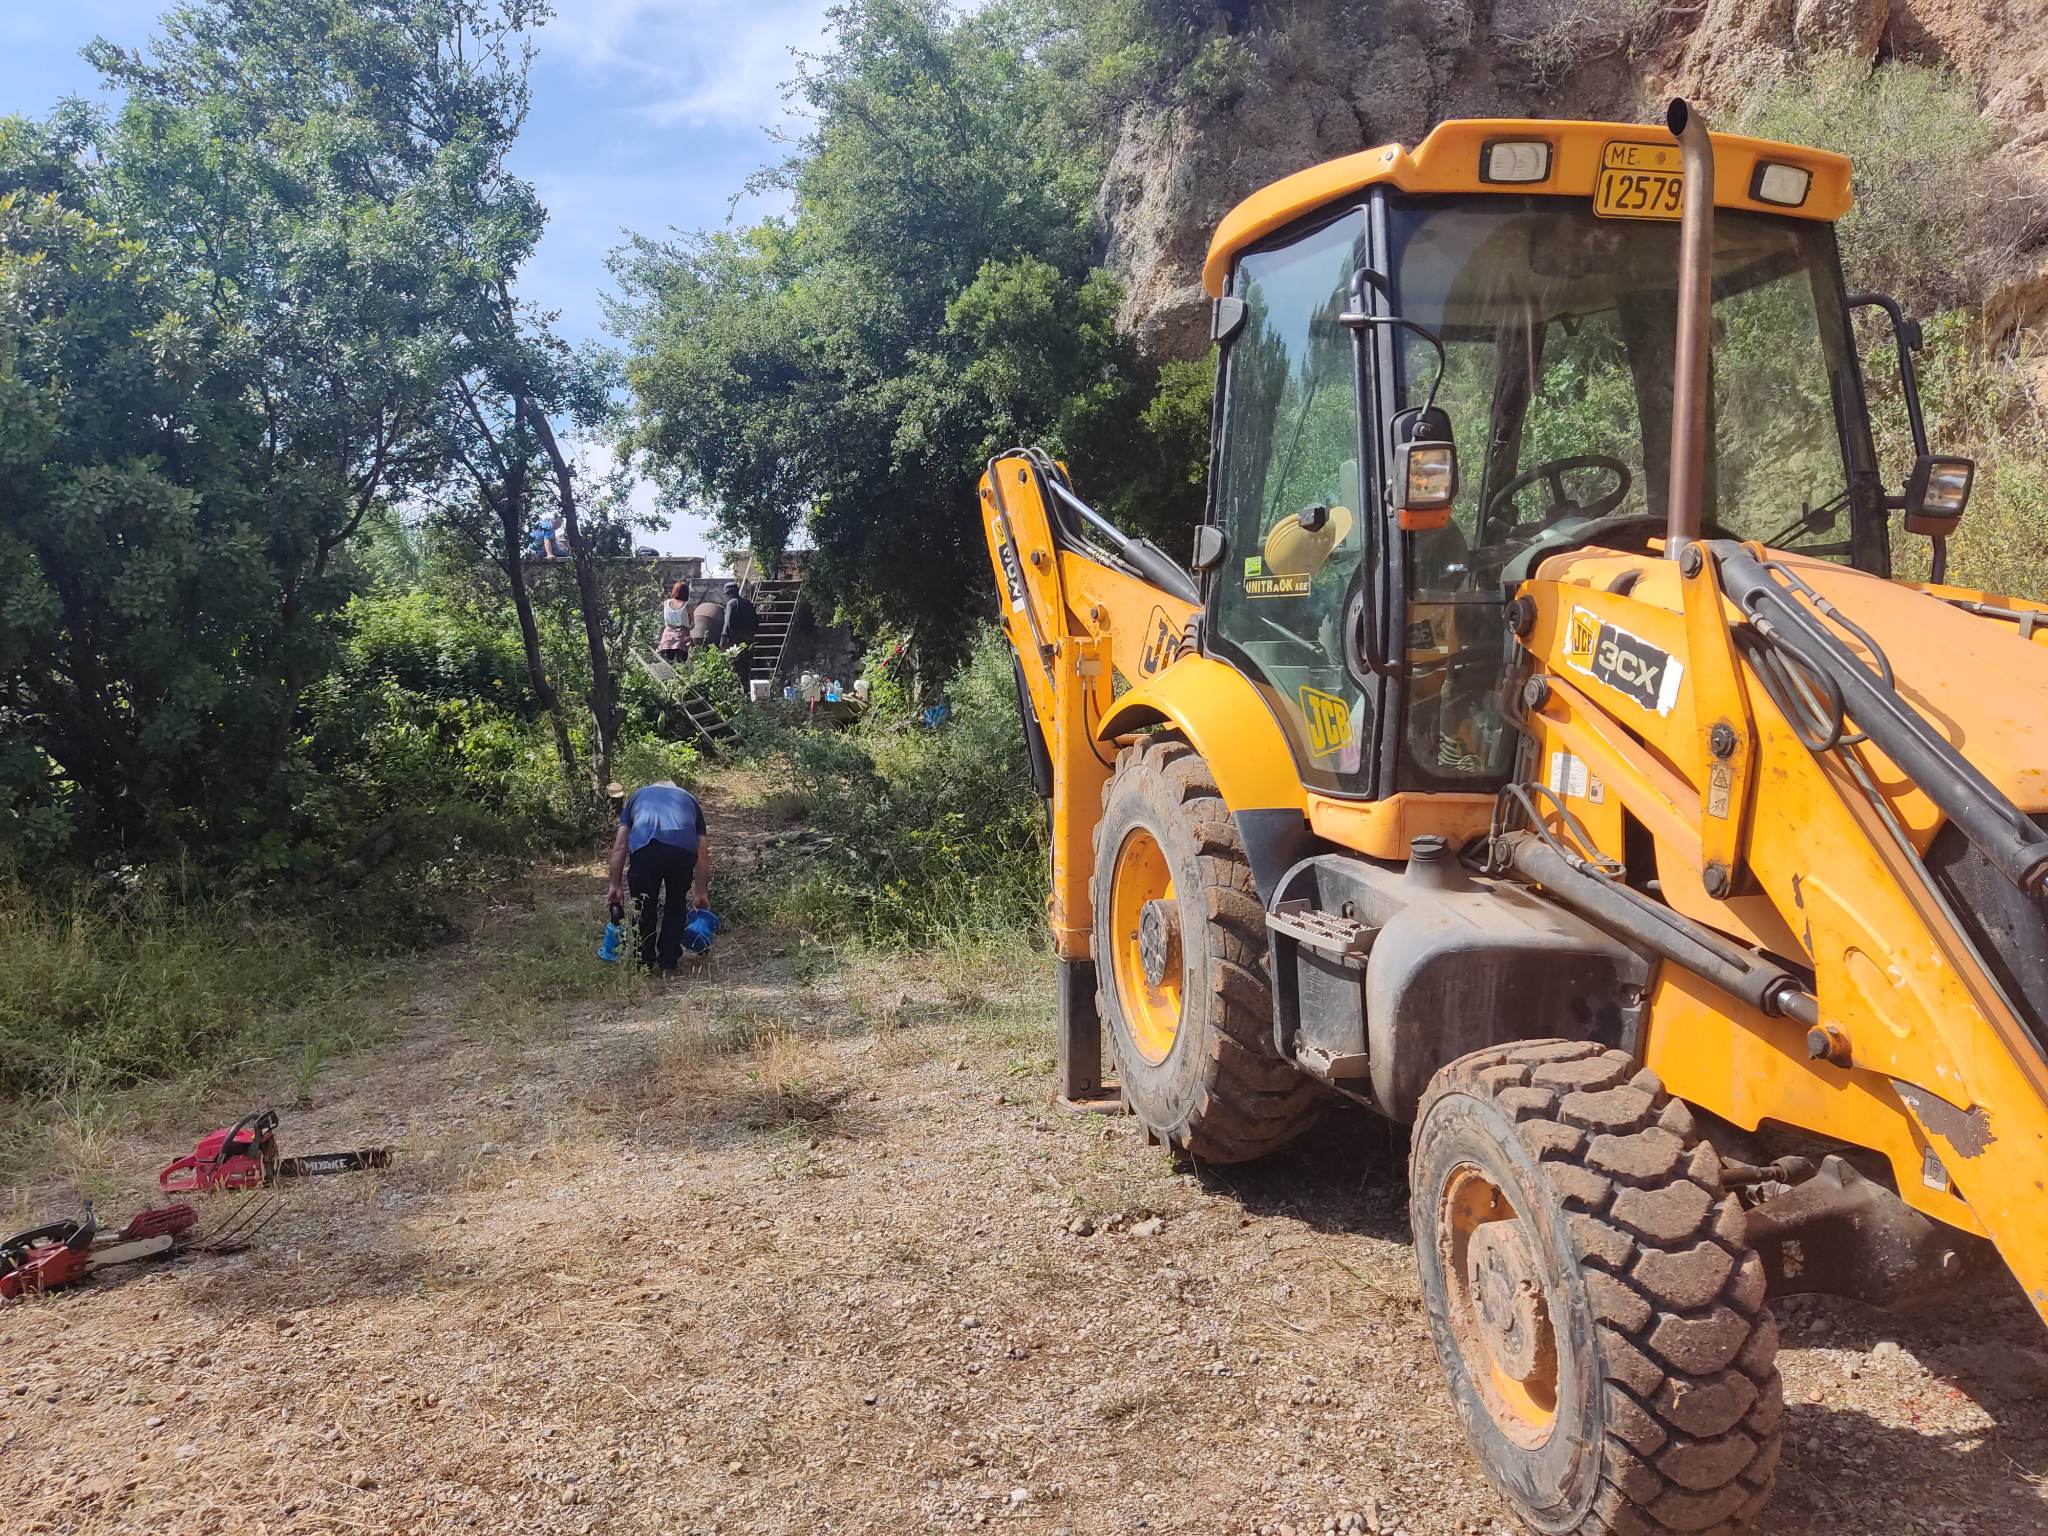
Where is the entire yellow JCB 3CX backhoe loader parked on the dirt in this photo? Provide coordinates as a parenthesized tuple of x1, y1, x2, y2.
(981, 102, 2048, 1536)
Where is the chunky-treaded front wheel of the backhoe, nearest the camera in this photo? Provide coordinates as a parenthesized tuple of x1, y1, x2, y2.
(1409, 1040, 1784, 1536)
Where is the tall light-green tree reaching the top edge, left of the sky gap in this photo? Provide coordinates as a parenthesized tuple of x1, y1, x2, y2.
(86, 0, 549, 768)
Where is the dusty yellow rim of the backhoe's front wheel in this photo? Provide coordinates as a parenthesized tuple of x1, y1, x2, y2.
(1438, 1163, 1559, 1448)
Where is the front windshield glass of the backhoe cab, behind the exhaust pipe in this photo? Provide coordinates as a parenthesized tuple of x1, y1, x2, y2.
(1386, 197, 1868, 788)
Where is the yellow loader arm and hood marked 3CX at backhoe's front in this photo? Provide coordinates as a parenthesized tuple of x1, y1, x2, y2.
(1518, 541, 2048, 1317)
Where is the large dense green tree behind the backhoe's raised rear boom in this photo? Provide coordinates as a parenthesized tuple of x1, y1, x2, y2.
(614, 0, 1206, 643)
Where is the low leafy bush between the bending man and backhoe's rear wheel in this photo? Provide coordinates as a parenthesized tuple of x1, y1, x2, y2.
(739, 629, 1047, 946)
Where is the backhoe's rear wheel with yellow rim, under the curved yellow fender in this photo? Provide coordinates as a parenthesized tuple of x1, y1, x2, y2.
(1092, 735, 1323, 1163)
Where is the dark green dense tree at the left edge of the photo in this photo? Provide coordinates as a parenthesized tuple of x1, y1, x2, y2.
(0, 141, 328, 856)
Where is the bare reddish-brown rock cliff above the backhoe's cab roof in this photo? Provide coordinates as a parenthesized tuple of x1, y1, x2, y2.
(1102, 0, 2048, 360)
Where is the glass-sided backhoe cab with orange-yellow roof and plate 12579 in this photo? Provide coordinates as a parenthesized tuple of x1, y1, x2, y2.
(1198, 121, 1966, 799)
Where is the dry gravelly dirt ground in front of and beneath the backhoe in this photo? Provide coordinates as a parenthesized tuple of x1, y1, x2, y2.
(0, 860, 2048, 1536)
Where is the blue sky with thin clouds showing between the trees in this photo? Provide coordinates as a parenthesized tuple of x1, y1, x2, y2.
(0, 0, 827, 555)
